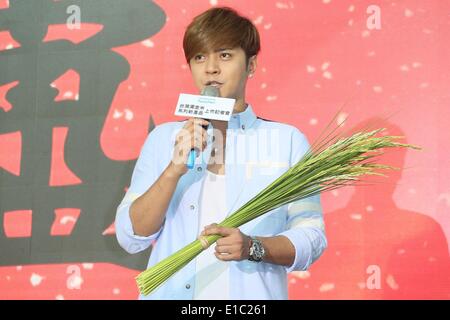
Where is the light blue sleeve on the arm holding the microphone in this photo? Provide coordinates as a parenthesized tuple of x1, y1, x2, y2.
(115, 127, 163, 253)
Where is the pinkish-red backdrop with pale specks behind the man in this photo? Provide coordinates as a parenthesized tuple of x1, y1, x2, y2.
(0, 0, 450, 299)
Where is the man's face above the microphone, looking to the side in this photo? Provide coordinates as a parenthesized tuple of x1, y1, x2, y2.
(189, 48, 256, 103)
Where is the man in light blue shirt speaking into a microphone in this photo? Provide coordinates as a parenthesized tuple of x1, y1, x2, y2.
(116, 8, 326, 299)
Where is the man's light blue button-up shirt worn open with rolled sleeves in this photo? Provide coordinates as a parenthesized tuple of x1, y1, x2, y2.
(115, 105, 327, 300)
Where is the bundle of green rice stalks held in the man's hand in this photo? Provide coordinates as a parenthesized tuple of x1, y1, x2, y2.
(136, 118, 420, 295)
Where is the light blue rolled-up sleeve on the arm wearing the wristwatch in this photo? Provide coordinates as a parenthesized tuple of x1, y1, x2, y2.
(280, 130, 327, 272)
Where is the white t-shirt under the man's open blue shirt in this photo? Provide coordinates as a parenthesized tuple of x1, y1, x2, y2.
(194, 170, 229, 300)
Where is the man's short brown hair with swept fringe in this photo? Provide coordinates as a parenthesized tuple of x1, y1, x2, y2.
(183, 7, 261, 63)
